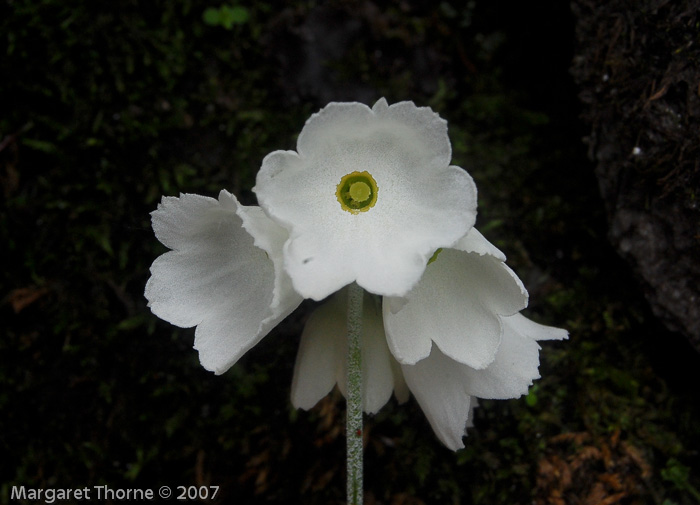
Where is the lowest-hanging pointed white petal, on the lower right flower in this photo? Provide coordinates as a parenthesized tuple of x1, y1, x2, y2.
(401, 348, 472, 451)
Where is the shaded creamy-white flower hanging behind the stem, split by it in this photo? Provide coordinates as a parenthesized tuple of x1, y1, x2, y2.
(292, 290, 406, 414)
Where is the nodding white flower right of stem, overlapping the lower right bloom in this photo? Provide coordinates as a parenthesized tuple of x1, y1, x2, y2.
(384, 249, 527, 369)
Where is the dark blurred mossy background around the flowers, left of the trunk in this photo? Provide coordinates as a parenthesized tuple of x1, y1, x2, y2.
(0, 0, 700, 505)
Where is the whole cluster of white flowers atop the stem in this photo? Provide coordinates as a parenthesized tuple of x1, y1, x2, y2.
(145, 99, 567, 450)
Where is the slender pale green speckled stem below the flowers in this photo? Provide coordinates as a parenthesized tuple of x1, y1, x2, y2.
(346, 282, 364, 505)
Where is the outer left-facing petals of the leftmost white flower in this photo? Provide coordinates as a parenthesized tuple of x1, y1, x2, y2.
(145, 191, 301, 374)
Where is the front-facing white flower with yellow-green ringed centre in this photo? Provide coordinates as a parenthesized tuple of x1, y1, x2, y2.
(254, 99, 476, 300)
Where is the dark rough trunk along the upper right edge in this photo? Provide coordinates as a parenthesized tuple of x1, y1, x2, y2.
(572, 0, 700, 352)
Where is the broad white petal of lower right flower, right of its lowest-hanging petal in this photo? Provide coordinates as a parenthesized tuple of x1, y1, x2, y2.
(463, 318, 540, 400)
